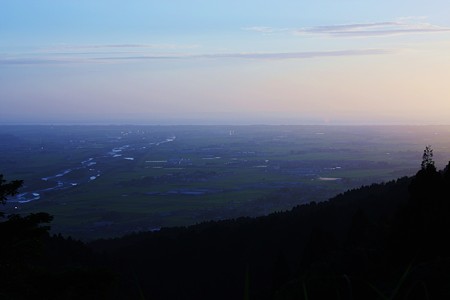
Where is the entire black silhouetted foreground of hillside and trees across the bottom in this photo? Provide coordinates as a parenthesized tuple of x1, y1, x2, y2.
(0, 157, 450, 300)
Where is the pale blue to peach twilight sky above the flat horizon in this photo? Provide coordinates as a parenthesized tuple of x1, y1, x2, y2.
(0, 0, 450, 125)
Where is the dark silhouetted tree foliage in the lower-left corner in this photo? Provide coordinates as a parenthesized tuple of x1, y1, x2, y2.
(0, 175, 114, 299)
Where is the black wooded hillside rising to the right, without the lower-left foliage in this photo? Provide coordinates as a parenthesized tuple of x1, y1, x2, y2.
(91, 158, 450, 299)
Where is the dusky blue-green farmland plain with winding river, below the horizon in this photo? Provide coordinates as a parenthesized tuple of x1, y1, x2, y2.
(0, 125, 450, 239)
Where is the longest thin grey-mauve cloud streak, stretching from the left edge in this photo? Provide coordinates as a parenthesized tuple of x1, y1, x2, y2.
(0, 49, 397, 65)
